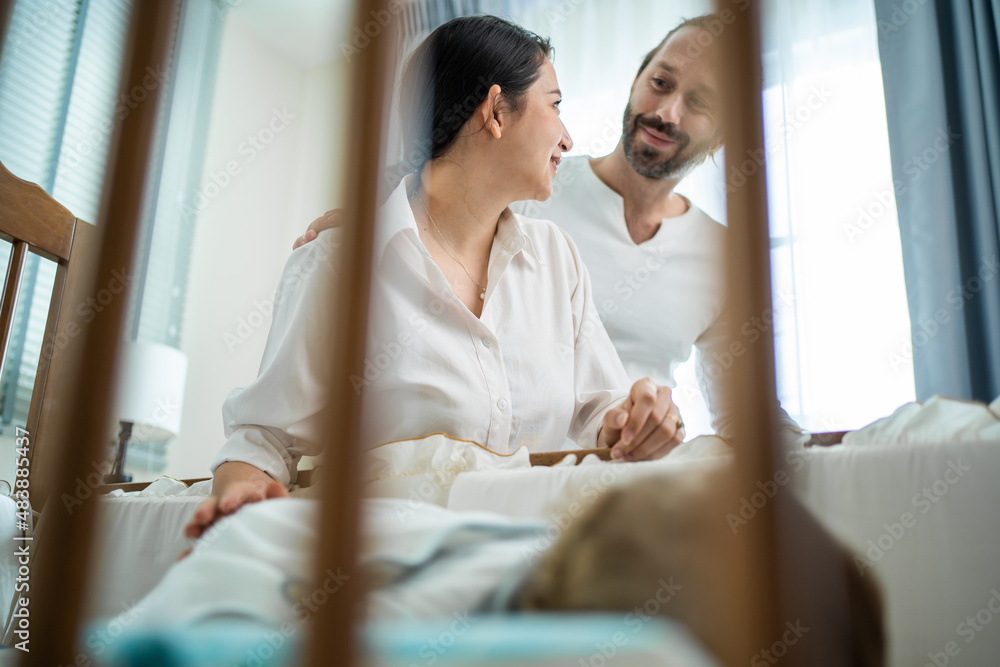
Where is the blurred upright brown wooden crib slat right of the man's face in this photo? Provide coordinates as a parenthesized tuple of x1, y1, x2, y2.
(716, 1, 781, 665)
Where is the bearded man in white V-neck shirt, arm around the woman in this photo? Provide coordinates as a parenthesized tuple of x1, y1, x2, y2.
(294, 14, 798, 444)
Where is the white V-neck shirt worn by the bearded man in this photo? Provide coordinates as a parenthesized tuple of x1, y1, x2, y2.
(512, 157, 795, 437)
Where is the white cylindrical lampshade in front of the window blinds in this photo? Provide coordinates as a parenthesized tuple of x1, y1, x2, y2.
(114, 341, 187, 441)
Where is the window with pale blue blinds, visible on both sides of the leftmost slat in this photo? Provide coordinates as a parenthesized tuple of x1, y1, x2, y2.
(0, 0, 224, 475)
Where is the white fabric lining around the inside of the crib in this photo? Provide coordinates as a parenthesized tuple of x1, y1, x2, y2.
(80, 399, 1000, 667)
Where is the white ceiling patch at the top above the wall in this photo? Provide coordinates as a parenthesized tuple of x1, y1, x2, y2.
(230, 0, 355, 68)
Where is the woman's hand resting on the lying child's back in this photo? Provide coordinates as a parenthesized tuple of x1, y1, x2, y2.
(184, 461, 288, 540)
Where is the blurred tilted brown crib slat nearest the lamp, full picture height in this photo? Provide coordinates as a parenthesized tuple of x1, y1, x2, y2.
(24, 0, 176, 667)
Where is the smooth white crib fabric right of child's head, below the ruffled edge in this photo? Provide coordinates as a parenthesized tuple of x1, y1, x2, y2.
(797, 442, 1000, 667)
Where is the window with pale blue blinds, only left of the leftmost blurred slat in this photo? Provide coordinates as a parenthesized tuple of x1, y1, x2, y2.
(0, 0, 130, 482)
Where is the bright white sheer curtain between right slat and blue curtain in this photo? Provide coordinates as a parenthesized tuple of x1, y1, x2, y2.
(760, 0, 914, 430)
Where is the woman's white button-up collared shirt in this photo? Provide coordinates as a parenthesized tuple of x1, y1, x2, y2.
(212, 178, 630, 484)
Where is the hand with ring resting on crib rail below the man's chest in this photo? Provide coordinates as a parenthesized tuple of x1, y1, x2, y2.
(597, 378, 684, 461)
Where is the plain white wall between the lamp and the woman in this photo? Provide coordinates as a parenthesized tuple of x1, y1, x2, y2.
(164, 14, 347, 478)
